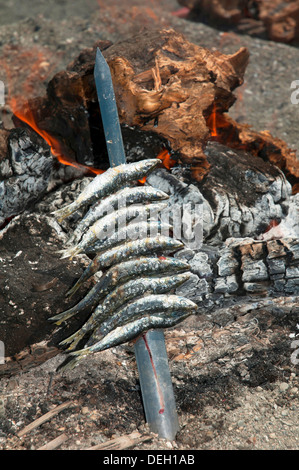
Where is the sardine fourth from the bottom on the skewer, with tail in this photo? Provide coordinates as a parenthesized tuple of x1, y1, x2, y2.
(49, 257, 190, 325)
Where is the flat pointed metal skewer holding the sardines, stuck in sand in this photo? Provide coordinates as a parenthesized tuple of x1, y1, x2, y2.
(94, 49, 179, 440)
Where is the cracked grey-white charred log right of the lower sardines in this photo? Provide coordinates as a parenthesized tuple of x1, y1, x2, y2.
(176, 238, 299, 318)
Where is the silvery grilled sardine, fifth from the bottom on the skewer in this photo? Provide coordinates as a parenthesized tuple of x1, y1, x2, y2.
(67, 236, 184, 296)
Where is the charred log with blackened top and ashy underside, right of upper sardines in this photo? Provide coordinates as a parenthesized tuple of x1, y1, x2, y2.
(148, 142, 298, 245)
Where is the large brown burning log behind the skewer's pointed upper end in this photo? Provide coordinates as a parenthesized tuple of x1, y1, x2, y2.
(11, 30, 248, 179)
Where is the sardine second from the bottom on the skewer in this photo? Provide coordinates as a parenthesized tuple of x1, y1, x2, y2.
(92, 294, 198, 338)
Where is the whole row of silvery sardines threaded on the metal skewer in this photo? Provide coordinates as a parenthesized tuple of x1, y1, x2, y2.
(50, 159, 197, 368)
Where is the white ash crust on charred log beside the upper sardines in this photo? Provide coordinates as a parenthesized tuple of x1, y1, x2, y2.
(147, 164, 291, 249)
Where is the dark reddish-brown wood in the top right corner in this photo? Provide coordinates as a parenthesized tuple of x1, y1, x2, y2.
(178, 0, 299, 43)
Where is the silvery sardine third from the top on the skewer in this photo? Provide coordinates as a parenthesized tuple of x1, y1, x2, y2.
(62, 203, 167, 259)
